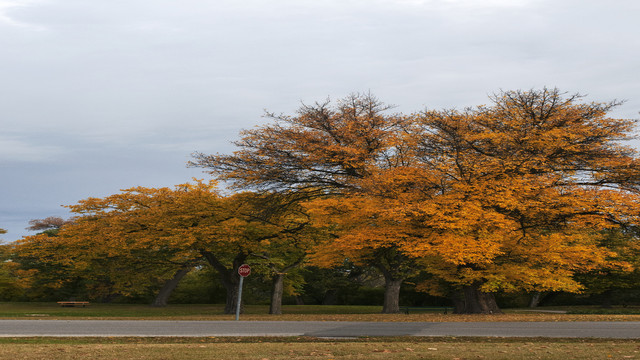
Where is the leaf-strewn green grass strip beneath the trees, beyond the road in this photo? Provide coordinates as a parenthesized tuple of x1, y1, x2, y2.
(0, 302, 640, 322)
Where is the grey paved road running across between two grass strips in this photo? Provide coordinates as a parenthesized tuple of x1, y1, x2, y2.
(0, 320, 640, 339)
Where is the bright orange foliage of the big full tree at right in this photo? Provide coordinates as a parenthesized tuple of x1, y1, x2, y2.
(305, 89, 640, 292)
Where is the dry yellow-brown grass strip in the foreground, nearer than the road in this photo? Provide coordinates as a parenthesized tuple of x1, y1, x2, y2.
(0, 337, 640, 360)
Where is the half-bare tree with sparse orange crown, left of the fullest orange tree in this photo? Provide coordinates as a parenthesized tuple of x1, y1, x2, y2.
(192, 94, 420, 312)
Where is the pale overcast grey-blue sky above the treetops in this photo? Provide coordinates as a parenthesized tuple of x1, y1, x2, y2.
(0, 0, 640, 242)
